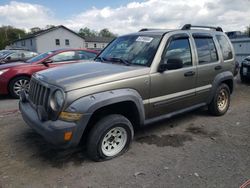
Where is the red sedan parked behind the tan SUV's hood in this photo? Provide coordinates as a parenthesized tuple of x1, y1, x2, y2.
(0, 49, 98, 98)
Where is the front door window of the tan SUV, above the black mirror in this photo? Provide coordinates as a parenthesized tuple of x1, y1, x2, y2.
(163, 38, 192, 69)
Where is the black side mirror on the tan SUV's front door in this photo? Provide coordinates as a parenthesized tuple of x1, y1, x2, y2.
(158, 59, 183, 72)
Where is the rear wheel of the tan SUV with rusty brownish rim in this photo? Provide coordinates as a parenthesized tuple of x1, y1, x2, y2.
(208, 84, 230, 116)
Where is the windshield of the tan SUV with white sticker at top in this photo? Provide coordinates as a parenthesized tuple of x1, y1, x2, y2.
(96, 35, 161, 66)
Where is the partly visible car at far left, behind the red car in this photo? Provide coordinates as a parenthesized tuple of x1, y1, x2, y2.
(0, 50, 38, 64)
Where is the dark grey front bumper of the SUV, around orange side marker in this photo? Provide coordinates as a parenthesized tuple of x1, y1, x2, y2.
(19, 101, 90, 148)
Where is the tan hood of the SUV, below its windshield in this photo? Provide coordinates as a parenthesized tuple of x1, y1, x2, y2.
(35, 62, 150, 91)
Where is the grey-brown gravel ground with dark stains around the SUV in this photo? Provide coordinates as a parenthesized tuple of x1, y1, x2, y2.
(0, 78, 250, 188)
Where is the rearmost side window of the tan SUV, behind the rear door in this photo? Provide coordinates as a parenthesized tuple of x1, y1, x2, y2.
(216, 35, 233, 60)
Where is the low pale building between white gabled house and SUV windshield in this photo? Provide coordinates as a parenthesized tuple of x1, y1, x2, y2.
(84, 37, 114, 50)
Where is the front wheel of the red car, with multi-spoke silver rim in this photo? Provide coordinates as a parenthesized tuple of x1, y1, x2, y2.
(9, 76, 30, 99)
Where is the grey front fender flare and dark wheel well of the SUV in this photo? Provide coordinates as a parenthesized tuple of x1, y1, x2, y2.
(66, 89, 145, 143)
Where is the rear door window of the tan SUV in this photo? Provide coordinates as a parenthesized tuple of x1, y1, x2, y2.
(194, 37, 218, 64)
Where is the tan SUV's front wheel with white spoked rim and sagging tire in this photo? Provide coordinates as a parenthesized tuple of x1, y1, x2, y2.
(87, 114, 134, 161)
